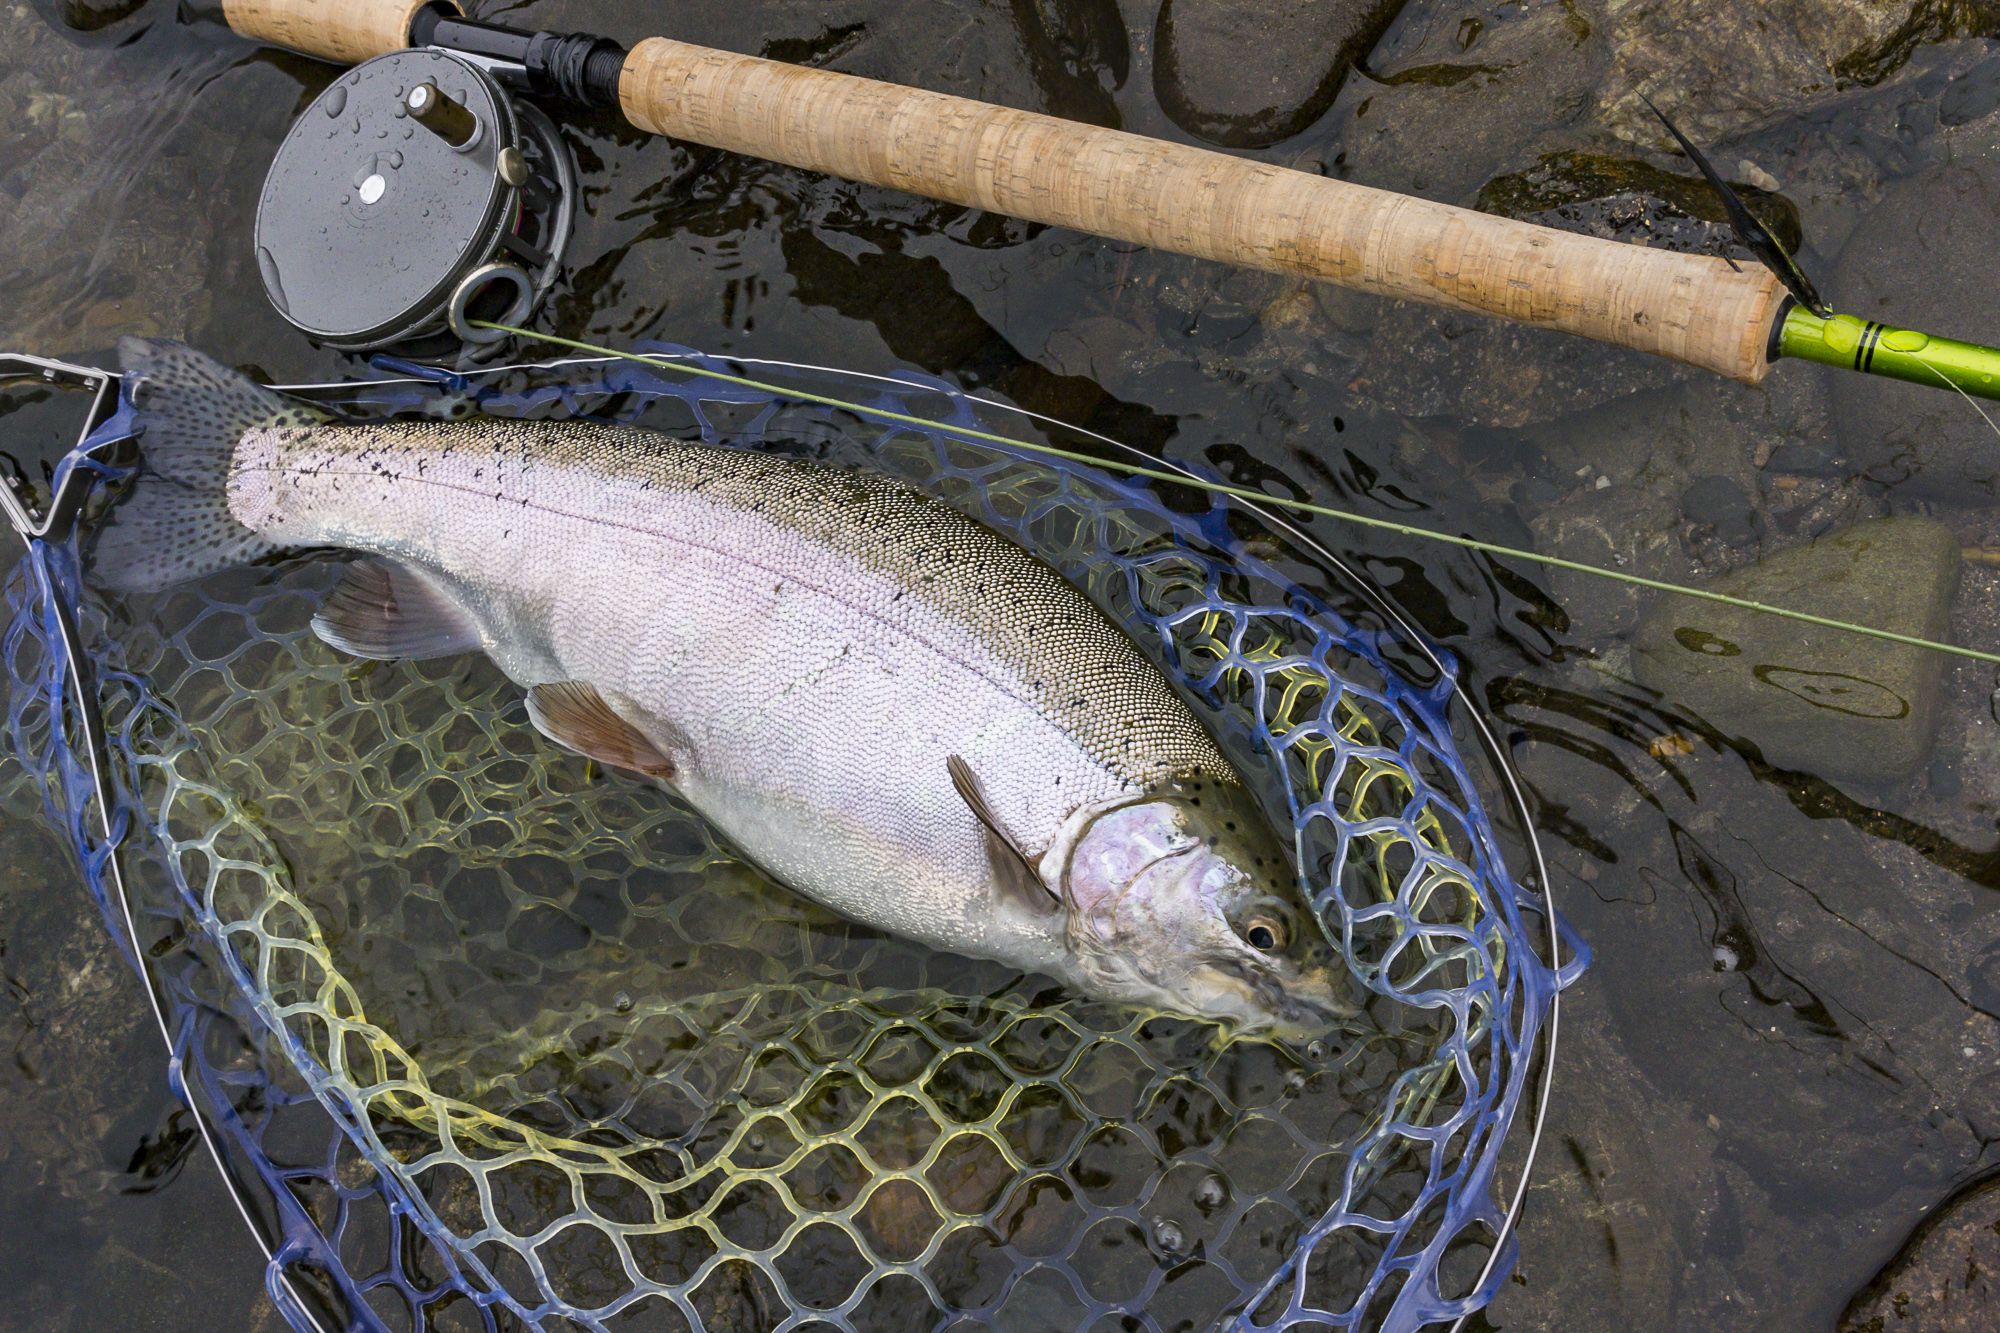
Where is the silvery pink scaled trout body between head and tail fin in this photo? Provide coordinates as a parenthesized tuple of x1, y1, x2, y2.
(230, 422, 1228, 975)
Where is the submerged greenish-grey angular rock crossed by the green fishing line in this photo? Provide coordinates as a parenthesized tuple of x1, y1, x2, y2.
(1634, 518, 1960, 781)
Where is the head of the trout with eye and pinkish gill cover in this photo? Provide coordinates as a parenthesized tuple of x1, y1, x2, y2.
(1056, 777, 1354, 1039)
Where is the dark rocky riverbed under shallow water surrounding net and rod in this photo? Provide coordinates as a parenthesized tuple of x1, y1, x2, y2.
(11, 0, 2000, 1331)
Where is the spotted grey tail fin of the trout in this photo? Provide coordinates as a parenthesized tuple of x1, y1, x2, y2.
(92, 338, 326, 592)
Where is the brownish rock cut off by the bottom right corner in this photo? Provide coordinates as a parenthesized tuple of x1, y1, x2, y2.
(1840, 1177, 2000, 1333)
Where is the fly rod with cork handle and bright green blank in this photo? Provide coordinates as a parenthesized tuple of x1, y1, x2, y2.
(207, 0, 2000, 398)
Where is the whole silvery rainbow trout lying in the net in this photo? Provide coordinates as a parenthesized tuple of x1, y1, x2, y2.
(94, 342, 1350, 1033)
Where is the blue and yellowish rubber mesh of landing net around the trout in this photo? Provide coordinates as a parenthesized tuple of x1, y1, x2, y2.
(0, 352, 1582, 1331)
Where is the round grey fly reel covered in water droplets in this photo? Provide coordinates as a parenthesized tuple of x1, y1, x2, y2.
(256, 48, 576, 360)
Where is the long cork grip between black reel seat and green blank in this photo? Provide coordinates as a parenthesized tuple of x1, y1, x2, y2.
(620, 38, 1784, 384)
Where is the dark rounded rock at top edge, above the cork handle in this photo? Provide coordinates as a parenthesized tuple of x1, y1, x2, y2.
(1152, 0, 1404, 148)
